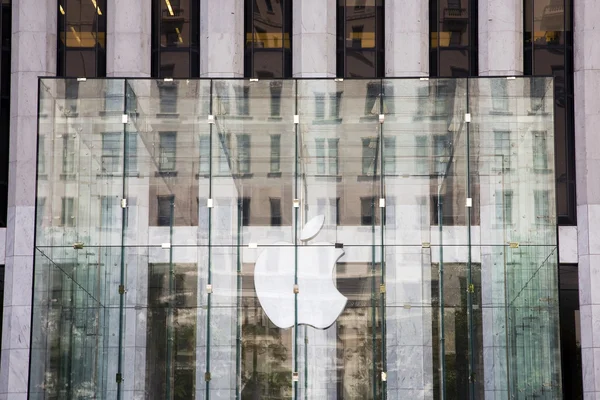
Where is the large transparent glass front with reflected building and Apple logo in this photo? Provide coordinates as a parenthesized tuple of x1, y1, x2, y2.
(29, 78, 561, 400)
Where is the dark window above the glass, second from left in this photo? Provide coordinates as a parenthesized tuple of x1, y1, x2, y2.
(152, 0, 200, 78)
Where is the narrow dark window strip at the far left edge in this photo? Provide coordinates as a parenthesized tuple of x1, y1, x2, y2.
(0, 0, 10, 227)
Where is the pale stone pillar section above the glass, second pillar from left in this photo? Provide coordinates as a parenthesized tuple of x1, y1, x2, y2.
(106, 0, 152, 77)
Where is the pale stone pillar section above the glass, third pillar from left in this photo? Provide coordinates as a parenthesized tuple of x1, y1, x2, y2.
(200, 0, 244, 78)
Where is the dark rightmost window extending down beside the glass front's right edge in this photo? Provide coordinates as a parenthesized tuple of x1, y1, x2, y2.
(523, 0, 576, 224)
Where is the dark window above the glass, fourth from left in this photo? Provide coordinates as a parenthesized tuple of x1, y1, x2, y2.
(337, 0, 384, 78)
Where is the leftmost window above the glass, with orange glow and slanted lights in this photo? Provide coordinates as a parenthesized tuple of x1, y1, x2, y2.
(56, 0, 107, 78)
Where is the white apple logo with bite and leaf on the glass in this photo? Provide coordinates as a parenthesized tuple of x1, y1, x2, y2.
(254, 215, 348, 329)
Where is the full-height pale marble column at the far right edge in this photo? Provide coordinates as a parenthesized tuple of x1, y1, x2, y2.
(573, 0, 600, 399)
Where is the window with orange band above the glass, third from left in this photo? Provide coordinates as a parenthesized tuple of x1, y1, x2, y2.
(244, 0, 292, 78)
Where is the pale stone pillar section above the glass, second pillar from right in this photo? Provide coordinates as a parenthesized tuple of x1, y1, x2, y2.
(478, 0, 523, 76)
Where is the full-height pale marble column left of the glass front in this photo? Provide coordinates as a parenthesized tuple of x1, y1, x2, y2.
(0, 0, 56, 400)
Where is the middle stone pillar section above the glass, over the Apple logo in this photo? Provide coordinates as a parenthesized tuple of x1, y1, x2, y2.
(292, 0, 337, 78)
